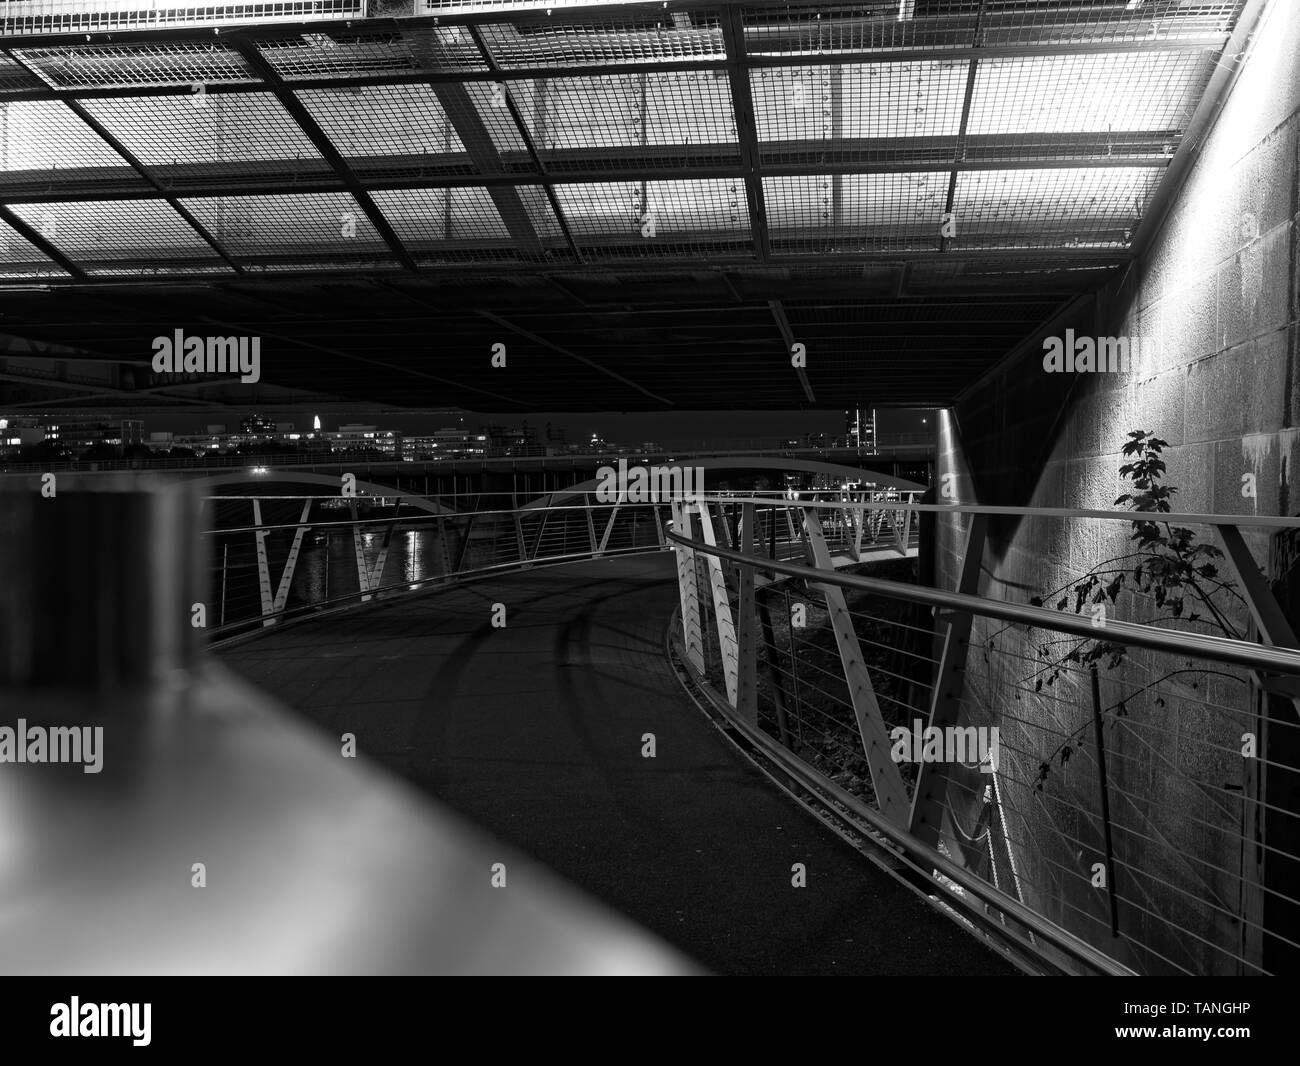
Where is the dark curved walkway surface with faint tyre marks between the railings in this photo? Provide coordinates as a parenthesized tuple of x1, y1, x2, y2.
(222, 553, 1015, 975)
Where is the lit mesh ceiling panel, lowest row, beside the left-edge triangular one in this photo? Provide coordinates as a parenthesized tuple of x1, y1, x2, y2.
(12, 200, 220, 274)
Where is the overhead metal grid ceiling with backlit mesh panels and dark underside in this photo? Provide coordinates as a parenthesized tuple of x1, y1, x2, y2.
(0, 0, 1248, 410)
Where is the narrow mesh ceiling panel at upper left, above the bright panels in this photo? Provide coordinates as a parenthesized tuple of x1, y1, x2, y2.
(13, 42, 257, 88)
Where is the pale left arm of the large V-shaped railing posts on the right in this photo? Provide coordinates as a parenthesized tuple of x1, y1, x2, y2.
(803, 506, 907, 826)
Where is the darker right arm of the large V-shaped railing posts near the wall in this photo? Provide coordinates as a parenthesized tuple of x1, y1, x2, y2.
(910, 515, 988, 854)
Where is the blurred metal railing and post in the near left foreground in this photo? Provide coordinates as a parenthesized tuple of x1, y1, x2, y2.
(0, 476, 697, 979)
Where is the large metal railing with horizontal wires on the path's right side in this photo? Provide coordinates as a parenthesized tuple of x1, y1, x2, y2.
(670, 497, 1300, 975)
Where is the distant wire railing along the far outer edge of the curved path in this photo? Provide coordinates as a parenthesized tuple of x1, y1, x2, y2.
(203, 490, 919, 637)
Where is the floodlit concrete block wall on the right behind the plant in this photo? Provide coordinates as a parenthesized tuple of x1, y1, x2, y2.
(936, 0, 1300, 974)
